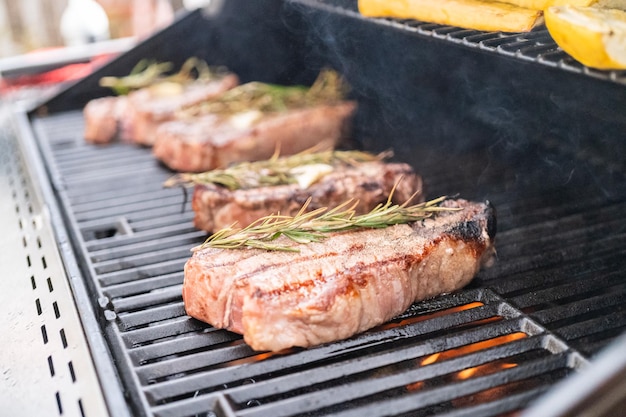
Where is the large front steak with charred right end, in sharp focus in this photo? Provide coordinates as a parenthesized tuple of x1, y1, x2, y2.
(183, 200, 496, 351)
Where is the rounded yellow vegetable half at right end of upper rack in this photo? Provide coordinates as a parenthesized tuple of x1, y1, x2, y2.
(545, 5, 626, 69)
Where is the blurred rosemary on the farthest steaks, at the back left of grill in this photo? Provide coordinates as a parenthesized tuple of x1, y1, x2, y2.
(100, 57, 220, 95)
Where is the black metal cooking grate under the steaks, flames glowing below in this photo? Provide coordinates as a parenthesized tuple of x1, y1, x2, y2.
(26, 108, 626, 417)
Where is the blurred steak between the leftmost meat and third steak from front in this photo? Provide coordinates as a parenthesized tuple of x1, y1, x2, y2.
(128, 73, 239, 146)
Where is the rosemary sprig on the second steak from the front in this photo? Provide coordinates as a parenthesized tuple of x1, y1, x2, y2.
(164, 148, 392, 190)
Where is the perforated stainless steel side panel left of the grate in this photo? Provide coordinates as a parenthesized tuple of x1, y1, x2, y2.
(0, 108, 108, 417)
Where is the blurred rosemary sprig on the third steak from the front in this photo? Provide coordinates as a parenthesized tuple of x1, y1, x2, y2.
(181, 70, 348, 117)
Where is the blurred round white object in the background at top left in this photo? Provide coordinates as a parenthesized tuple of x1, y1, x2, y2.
(61, 0, 110, 46)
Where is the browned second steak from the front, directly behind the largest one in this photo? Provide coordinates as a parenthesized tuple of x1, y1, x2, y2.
(192, 161, 423, 232)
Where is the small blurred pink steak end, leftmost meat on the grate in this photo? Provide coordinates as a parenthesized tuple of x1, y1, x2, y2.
(83, 96, 128, 143)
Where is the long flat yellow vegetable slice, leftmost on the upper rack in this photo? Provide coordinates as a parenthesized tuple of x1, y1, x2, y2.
(358, 0, 546, 32)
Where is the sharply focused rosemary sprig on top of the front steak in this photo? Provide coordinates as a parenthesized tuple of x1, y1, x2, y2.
(192, 193, 456, 252)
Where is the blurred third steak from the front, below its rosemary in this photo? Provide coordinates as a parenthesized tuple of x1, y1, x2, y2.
(153, 101, 356, 172)
